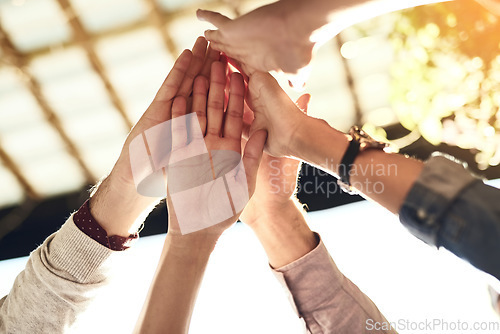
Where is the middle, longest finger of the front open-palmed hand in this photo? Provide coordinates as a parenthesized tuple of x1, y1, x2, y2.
(207, 61, 226, 136)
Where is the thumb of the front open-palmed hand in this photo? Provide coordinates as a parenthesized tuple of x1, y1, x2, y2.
(242, 130, 267, 197)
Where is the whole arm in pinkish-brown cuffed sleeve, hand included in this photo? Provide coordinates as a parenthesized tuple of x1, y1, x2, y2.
(241, 98, 393, 333)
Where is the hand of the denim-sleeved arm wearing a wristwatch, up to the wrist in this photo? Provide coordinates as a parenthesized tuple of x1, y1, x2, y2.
(247, 72, 307, 157)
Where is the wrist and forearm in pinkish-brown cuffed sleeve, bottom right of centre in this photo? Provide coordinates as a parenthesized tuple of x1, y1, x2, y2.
(250, 200, 393, 333)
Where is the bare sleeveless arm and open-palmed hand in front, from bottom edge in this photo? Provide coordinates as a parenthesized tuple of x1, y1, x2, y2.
(135, 62, 266, 333)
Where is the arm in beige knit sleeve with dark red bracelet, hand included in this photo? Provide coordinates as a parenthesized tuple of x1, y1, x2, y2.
(0, 38, 211, 333)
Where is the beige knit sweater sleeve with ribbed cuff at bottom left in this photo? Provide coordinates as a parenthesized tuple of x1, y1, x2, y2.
(0, 216, 115, 334)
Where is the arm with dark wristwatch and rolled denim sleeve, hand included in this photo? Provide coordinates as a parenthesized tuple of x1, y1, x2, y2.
(248, 73, 500, 278)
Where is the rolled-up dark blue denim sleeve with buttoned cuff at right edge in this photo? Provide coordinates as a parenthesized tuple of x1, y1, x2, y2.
(399, 154, 500, 279)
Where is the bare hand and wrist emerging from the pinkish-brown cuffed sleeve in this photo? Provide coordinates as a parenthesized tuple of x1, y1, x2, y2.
(240, 94, 318, 268)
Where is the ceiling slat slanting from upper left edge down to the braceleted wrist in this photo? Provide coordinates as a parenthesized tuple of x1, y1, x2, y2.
(0, 26, 97, 183)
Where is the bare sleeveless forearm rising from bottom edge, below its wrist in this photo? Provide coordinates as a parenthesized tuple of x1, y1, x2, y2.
(135, 233, 217, 333)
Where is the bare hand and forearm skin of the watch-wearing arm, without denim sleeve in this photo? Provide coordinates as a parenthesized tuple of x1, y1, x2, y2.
(247, 72, 423, 213)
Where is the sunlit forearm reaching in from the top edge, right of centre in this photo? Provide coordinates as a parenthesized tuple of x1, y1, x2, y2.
(281, 0, 449, 42)
